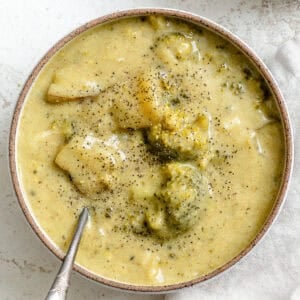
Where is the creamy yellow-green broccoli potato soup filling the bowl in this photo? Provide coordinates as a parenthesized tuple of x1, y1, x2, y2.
(17, 16, 285, 286)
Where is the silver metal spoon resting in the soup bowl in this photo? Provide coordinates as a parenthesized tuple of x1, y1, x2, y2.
(45, 207, 89, 300)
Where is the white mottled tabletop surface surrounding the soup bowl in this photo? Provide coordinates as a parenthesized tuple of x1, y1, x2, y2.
(0, 0, 300, 300)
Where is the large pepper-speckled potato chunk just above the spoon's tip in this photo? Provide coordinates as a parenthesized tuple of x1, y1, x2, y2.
(55, 135, 125, 195)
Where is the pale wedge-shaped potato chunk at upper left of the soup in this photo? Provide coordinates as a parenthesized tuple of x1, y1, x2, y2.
(47, 65, 103, 103)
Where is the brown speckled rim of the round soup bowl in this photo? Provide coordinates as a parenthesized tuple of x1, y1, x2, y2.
(9, 8, 293, 293)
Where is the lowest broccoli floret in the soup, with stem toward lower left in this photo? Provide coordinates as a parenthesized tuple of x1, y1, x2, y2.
(130, 162, 208, 240)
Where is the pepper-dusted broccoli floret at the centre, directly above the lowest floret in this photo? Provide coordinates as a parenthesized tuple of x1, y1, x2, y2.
(145, 111, 209, 161)
